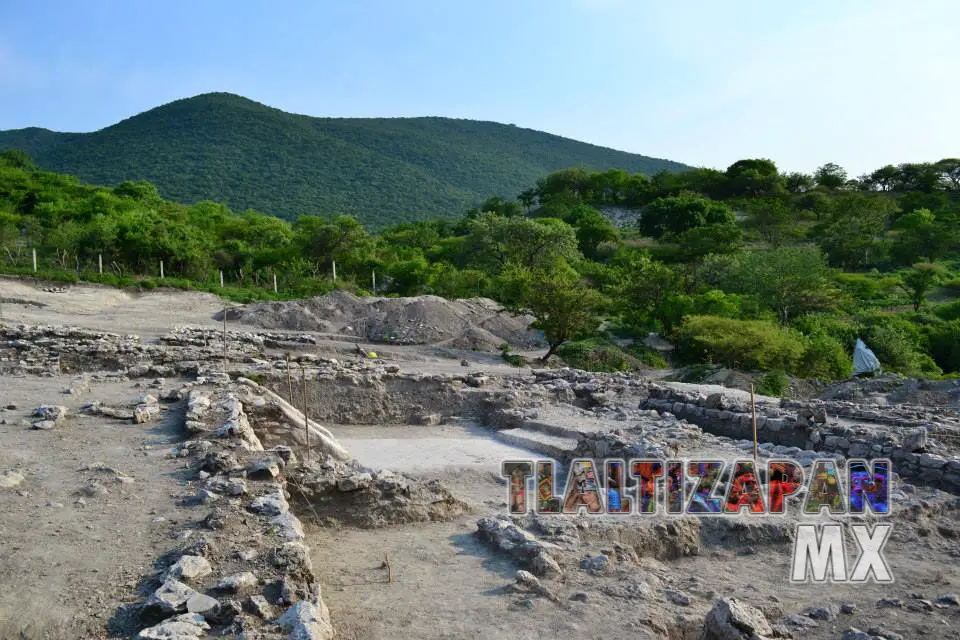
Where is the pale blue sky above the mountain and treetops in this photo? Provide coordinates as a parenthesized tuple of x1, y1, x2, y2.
(0, 0, 960, 175)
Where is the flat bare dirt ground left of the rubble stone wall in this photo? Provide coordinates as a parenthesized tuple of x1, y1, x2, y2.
(0, 378, 189, 640)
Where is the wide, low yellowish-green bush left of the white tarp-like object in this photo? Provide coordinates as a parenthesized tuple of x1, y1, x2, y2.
(677, 316, 806, 371)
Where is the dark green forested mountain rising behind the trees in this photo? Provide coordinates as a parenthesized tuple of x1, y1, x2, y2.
(0, 93, 689, 228)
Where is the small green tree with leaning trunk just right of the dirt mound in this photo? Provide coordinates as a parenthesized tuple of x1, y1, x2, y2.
(501, 261, 603, 363)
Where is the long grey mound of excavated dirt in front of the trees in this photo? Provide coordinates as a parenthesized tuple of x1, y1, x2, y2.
(220, 291, 545, 350)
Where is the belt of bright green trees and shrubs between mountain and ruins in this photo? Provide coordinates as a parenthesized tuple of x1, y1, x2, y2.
(0, 151, 960, 382)
